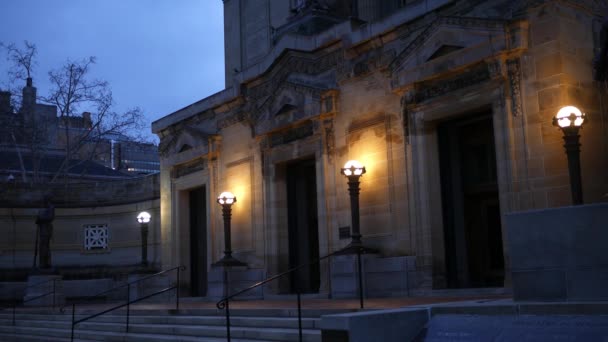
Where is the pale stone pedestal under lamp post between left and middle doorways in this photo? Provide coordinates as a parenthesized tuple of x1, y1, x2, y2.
(207, 266, 264, 299)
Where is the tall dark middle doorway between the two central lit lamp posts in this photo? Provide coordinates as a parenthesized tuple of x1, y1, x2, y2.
(286, 159, 320, 293)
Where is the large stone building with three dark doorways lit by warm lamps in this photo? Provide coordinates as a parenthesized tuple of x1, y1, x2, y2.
(152, 0, 608, 295)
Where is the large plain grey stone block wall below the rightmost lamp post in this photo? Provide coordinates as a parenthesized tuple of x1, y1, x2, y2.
(506, 203, 608, 301)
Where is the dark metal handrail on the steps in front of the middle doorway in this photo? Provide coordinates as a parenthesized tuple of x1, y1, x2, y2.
(215, 246, 365, 342)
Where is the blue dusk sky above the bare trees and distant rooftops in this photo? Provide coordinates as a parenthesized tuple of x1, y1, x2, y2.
(0, 0, 224, 141)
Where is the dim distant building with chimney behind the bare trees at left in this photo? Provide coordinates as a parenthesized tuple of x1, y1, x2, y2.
(0, 79, 159, 183)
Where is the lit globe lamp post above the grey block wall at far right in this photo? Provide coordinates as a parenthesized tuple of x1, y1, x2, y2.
(553, 106, 587, 205)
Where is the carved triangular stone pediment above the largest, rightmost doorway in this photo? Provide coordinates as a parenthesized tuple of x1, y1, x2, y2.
(390, 17, 526, 89)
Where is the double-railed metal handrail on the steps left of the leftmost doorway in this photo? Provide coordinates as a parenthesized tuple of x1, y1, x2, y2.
(70, 266, 186, 341)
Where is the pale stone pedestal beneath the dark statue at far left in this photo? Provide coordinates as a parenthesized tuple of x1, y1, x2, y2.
(23, 275, 65, 306)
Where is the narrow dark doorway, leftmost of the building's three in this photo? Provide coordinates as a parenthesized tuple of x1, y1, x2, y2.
(189, 186, 207, 297)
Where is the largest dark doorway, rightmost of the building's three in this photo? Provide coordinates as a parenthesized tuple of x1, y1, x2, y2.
(438, 113, 504, 288)
